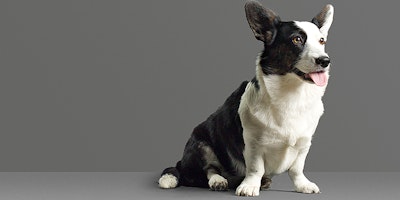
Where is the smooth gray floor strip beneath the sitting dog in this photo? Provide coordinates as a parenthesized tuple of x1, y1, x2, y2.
(0, 172, 400, 200)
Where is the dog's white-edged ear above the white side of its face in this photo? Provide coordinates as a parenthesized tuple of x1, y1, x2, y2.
(311, 4, 333, 37)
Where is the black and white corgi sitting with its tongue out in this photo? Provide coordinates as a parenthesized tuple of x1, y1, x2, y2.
(158, 1, 334, 196)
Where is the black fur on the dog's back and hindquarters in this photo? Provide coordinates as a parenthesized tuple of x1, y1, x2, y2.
(170, 81, 248, 187)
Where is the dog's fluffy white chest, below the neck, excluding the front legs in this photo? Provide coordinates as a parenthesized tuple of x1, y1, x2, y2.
(239, 76, 324, 175)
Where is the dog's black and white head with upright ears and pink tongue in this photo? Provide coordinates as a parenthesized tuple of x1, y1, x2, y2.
(245, 1, 333, 86)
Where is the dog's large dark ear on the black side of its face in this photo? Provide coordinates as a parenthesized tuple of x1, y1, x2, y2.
(244, 1, 280, 45)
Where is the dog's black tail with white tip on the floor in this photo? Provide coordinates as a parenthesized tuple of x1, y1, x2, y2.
(158, 161, 181, 189)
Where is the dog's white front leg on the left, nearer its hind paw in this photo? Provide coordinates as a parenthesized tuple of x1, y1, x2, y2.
(236, 139, 265, 196)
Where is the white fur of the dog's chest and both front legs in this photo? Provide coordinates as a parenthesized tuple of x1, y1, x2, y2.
(236, 52, 326, 196)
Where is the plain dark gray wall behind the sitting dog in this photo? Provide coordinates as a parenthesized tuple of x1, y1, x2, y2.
(0, 0, 400, 171)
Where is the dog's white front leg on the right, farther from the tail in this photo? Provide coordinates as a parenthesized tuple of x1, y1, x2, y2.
(289, 147, 320, 194)
